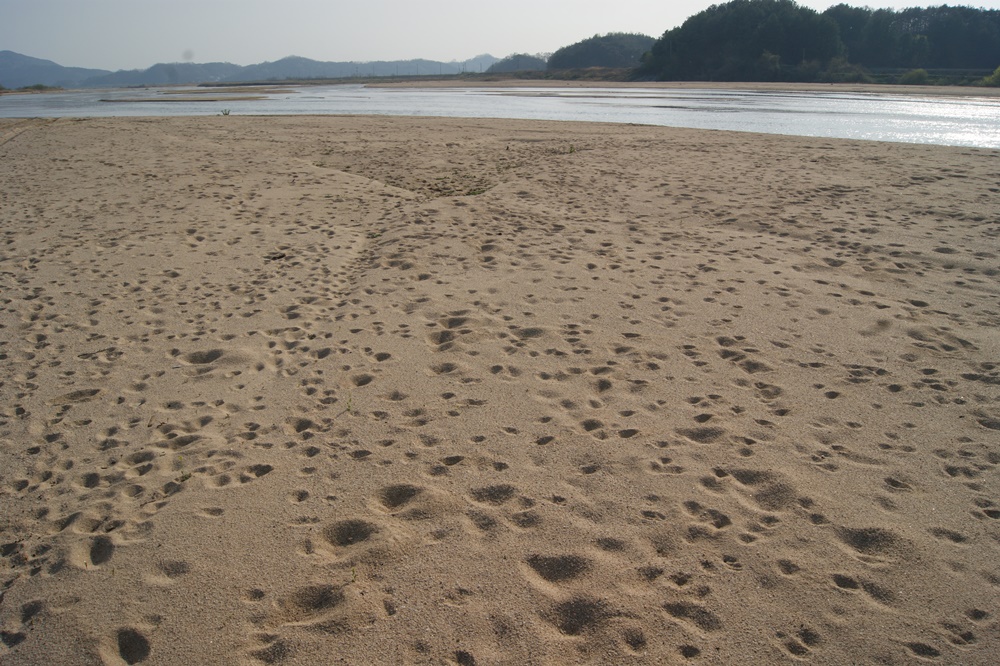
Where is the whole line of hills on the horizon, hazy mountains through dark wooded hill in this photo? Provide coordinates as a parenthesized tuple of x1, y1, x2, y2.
(7, 0, 1000, 88)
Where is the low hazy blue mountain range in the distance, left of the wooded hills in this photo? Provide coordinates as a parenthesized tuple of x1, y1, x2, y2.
(0, 51, 498, 88)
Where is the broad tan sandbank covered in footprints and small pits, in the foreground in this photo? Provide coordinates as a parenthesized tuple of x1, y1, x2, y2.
(0, 116, 1000, 666)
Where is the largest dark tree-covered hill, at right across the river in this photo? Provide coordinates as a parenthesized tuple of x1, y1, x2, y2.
(639, 0, 1000, 81)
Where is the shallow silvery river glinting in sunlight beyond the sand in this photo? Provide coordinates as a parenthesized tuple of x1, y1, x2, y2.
(0, 85, 1000, 149)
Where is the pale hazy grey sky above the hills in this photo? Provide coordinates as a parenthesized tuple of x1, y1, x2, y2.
(7, 0, 1000, 70)
